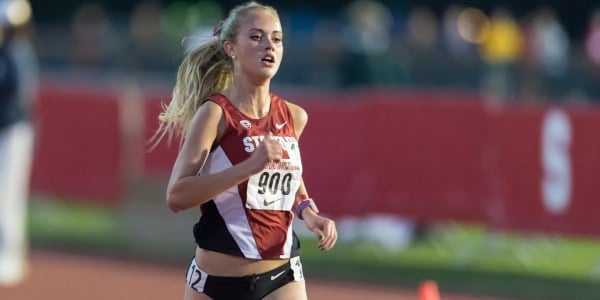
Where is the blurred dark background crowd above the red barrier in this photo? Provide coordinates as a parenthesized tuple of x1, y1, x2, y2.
(31, 0, 600, 102)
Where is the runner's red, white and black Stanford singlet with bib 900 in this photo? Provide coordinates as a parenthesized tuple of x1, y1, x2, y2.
(194, 94, 302, 259)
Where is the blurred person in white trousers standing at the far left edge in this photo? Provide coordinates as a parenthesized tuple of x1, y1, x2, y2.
(0, 0, 37, 285)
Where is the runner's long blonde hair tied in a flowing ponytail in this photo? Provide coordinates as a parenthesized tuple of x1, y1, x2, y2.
(151, 1, 278, 147)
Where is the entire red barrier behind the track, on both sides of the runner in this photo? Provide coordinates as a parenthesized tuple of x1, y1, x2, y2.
(32, 85, 600, 235)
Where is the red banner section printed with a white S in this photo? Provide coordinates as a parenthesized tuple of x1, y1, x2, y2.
(488, 107, 600, 235)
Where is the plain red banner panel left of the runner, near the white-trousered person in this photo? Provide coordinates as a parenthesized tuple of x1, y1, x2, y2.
(31, 83, 123, 203)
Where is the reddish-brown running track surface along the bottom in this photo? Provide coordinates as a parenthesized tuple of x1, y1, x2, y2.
(0, 251, 504, 300)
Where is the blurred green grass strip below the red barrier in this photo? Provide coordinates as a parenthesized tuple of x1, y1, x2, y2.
(29, 202, 600, 299)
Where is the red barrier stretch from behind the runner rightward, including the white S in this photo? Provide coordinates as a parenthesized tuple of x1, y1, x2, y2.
(146, 91, 600, 235)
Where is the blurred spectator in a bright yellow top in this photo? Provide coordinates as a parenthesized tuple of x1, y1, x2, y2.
(480, 8, 523, 101)
